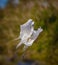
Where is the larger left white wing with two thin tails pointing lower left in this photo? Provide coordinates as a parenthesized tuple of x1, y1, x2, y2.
(16, 19, 34, 48)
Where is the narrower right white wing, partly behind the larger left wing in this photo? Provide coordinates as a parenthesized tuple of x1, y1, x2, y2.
(23, 27, 43, 50)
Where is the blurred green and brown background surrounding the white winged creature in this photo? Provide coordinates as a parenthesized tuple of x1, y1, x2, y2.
(0, 0, 58, 65)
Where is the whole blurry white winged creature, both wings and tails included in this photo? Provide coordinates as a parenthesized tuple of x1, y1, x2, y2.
(16, 19, 43, 50)
